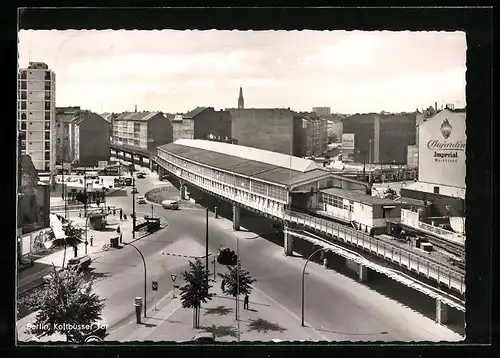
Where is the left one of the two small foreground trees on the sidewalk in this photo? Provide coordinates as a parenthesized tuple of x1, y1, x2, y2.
(179, 259, 214, 328)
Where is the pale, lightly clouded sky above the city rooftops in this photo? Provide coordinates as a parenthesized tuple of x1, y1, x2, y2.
(19, 30, 467, 114)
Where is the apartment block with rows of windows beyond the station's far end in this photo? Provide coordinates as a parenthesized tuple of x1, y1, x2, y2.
(112, 111, 173, 152)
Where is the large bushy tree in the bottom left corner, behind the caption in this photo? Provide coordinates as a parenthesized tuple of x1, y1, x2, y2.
(24, 266, 104, 342)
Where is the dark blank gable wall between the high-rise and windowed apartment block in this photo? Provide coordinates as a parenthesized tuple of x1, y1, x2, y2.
(77, 112, 111, 166)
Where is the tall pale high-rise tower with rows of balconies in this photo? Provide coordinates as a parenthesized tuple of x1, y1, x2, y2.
(17, 62, 56, 177)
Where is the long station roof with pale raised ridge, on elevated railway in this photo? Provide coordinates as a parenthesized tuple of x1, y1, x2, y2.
(159, 139, 329, 185)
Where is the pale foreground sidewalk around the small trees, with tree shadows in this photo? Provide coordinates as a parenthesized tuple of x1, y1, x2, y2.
(106, 280, 326, 342)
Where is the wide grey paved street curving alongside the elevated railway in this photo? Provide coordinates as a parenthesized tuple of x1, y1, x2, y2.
(20, 169, 462, 341)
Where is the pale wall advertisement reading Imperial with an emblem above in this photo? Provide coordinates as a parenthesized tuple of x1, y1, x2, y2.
(418, 110, 466, 188)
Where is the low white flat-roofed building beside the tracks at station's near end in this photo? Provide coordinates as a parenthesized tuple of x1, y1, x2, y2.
(315, 188, 401, 234)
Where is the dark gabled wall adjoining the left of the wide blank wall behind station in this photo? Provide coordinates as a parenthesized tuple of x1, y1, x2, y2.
(194, 107, 231, 139)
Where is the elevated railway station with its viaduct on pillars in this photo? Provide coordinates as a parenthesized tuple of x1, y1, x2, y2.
(152, 139, 465, 323)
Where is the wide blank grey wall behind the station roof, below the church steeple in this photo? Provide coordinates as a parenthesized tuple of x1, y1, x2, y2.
(229, 108, 302, 156)
